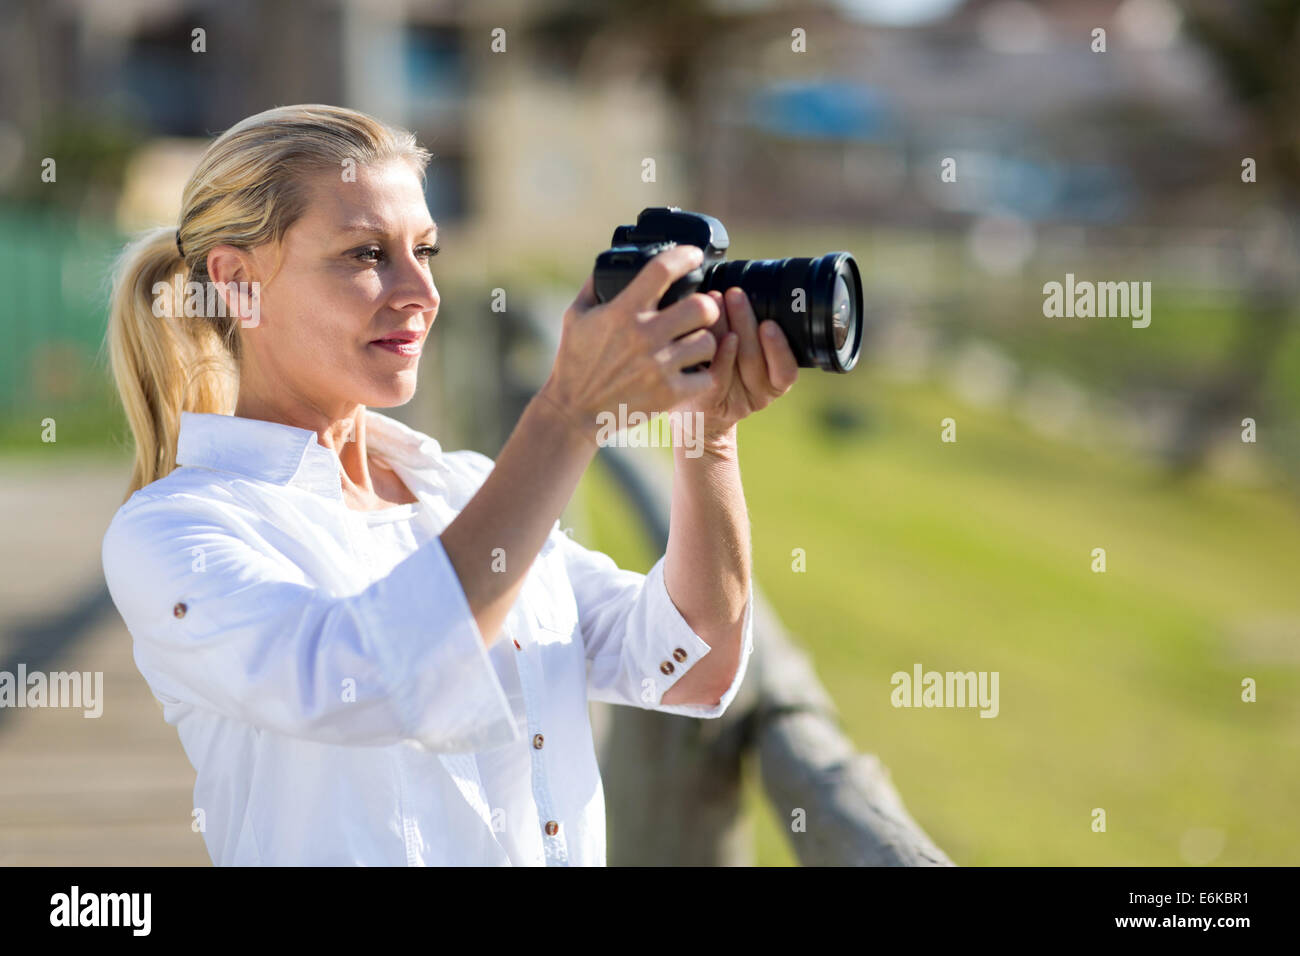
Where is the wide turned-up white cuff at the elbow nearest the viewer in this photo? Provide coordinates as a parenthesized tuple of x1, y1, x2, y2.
(355, 538, 523, 753)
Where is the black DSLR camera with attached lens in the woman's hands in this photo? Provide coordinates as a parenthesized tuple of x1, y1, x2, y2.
(593, 206, 862, 372)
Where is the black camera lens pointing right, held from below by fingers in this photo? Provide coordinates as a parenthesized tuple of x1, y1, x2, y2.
(699, 252, 862, 372)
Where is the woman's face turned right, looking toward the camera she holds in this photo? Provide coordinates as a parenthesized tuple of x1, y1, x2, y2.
(239, 161, 438, 416)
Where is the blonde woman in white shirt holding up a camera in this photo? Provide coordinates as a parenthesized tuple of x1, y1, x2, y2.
(103, 105, 797, 865)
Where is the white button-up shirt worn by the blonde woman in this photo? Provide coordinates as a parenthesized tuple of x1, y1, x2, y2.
(103, 410, 753, 866)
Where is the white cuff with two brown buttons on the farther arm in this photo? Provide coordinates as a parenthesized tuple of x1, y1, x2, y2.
(645, 555, 754, 718)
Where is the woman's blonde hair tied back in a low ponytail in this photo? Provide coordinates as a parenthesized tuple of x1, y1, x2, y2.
(107, 104, 430, 498)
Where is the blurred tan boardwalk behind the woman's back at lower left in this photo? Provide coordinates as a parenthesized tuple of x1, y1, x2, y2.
(0, 457, 211, 866)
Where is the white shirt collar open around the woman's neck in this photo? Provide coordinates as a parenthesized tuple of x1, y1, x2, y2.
(176, 408, 449, 499)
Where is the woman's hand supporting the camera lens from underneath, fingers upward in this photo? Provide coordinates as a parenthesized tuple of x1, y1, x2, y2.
(684, 280, 800, 437)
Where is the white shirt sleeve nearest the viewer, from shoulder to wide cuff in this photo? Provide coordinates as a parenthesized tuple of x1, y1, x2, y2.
(103, 498, 520, 753)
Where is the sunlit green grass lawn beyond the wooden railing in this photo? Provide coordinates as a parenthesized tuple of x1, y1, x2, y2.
(582, 371, 1300, 865)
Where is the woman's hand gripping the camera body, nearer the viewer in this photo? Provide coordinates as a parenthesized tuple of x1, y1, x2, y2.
(540, 246, 720, 441)
